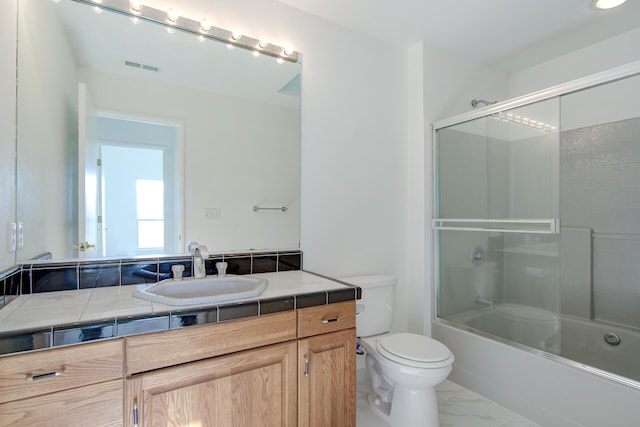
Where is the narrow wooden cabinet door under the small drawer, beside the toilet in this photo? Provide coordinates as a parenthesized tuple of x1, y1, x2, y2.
(298, 329, 356, 427)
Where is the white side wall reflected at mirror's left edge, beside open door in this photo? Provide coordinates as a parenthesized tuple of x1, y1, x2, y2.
(15, 2, 78, 260)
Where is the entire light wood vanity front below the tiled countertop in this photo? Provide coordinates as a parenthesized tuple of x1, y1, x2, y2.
(0, 301, 356, 427)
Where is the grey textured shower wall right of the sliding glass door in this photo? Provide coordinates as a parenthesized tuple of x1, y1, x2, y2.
(560, 118, 640, 325)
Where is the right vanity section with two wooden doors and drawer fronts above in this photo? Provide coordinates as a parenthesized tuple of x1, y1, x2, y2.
(125, 301, 356, 427)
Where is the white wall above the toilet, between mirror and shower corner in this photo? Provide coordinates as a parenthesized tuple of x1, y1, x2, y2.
(302, 21, 410, 329)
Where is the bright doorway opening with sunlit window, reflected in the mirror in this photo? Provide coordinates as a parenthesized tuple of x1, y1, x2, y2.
(96, 117, 182, 257)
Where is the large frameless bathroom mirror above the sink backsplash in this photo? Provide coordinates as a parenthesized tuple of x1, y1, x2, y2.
(16, 0, 301, 262)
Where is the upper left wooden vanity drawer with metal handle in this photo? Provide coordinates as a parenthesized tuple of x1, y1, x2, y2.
(0, 339, 124, 403)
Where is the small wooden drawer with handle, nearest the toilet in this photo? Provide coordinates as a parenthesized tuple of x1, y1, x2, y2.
(298, 301, 356, 338)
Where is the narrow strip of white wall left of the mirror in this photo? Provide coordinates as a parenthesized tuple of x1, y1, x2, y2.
(0, 1, 16, 271)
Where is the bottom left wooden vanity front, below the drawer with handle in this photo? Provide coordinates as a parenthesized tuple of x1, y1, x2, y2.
(0, 379, 124, 427)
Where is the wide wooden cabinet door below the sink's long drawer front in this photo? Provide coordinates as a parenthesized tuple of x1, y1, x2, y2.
(126, 341, 297, 427)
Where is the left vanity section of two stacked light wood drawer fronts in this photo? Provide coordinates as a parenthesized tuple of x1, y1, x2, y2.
(0, 339, 124, 426)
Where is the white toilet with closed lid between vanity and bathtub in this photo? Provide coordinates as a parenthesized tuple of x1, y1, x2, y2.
(340, 275, 453, 427)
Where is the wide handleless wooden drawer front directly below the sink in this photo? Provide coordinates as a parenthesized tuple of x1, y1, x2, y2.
(125, 311, 296, 375)
